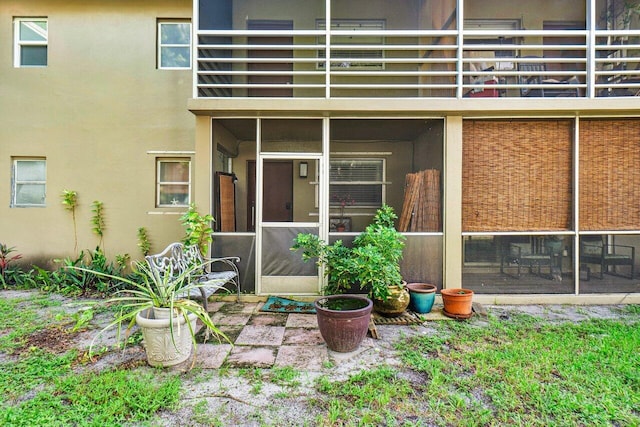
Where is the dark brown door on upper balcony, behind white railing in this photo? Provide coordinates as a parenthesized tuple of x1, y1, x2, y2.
(247, 20, 293, 97)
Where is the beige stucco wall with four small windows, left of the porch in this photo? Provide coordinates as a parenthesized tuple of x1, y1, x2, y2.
(0, 0, 194, 263)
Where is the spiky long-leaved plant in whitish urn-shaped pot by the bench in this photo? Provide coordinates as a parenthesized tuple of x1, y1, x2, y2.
(72, 262, 230, 367)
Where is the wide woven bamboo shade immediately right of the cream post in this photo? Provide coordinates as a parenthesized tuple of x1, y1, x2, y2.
(462, 120, 573, 232)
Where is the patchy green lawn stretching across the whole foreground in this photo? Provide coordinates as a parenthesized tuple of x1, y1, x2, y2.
(0, 295, 640, 426)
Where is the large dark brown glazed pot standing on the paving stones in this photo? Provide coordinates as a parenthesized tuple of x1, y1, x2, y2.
(314, 295, 373, 353)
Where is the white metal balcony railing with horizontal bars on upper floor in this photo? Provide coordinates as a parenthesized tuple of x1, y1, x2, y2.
(195, 30, 640, 98)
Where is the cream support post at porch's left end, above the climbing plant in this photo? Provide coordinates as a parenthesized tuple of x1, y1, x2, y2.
(191, 116, 215, 256)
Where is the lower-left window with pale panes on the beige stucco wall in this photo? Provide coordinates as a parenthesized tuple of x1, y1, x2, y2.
(11, 159, 47, 207)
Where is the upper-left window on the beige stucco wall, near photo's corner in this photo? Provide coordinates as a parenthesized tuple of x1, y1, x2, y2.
(14, 18, 49, 67)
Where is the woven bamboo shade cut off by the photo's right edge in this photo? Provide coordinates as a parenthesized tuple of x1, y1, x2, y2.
(579, 119, 640, 231)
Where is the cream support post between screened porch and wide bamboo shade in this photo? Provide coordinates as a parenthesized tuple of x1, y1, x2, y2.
(443, 116, 462, 288)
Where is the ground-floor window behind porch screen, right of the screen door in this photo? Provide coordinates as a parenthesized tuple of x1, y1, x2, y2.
(329, 158, 385, 208)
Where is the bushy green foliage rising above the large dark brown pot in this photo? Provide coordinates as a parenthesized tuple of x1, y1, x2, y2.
(291, 205, 405, 300)
